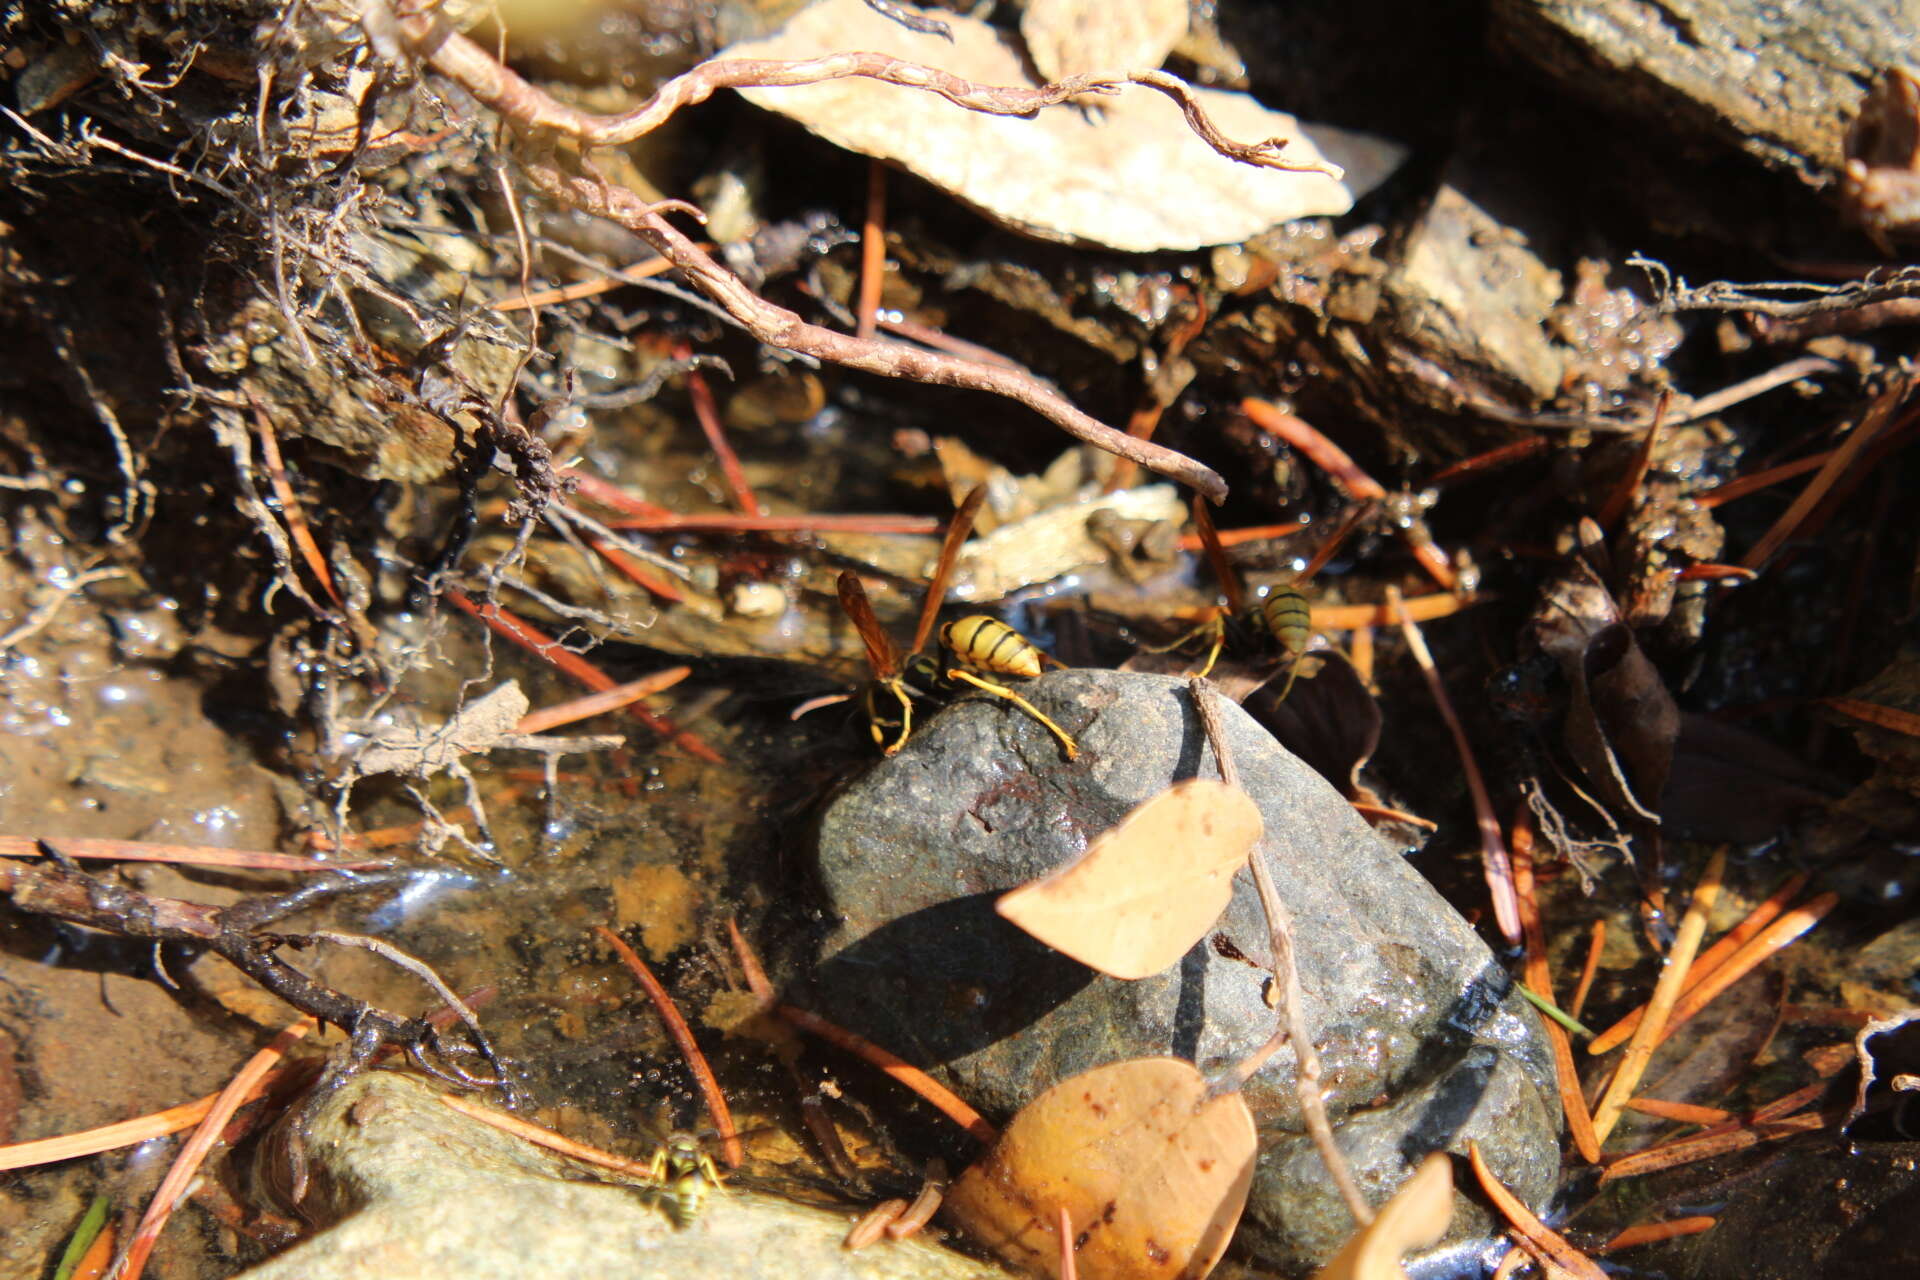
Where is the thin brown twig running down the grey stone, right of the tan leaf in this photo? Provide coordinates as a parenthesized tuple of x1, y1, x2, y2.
(1187, 679, 1373, 1226)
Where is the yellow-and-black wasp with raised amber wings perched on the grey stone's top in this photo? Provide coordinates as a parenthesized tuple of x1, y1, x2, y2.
(839, 486, 1079, 760)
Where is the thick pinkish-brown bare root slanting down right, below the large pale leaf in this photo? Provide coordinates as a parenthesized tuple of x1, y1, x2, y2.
(526, 157, 1227, 503)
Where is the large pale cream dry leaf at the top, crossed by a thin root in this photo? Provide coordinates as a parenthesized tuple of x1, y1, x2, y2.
(722, 0, 1405, 253)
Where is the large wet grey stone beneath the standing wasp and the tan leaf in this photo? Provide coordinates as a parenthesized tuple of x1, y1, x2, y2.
(814, 670, 1559, 1272)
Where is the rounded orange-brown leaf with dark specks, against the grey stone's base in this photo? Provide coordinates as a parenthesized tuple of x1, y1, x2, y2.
(943, 1057, 1258, 1280)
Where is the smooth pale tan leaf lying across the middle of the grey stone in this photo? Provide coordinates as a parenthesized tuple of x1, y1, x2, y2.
(993, 777, 1263, 979)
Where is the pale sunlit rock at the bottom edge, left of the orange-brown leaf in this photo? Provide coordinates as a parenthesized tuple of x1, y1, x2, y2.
(242, 1071, 1004, 1280)
